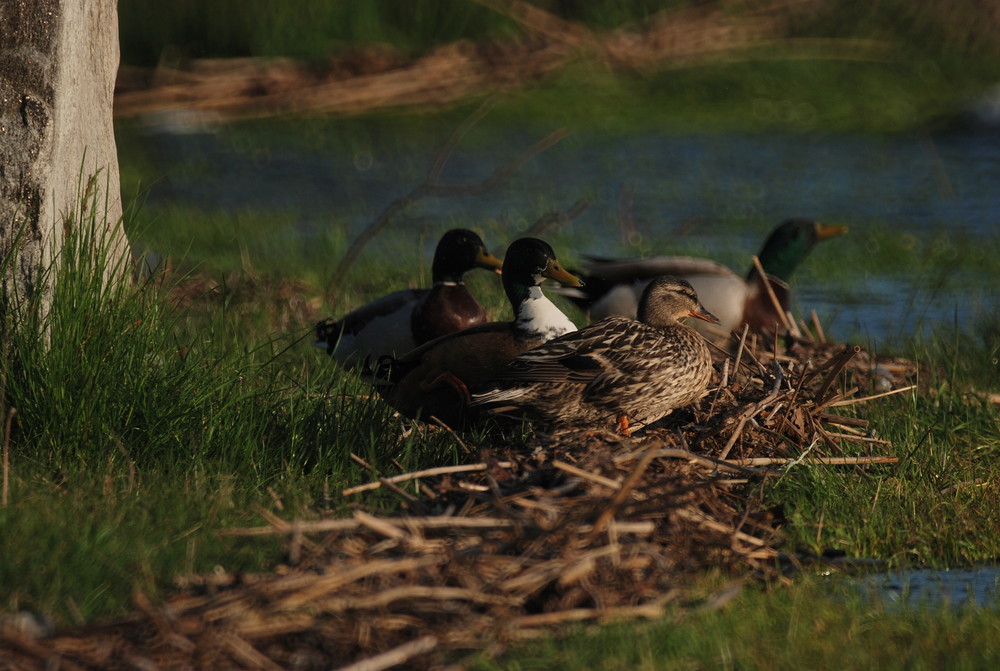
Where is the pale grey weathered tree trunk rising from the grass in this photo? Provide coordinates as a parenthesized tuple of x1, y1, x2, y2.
(0, 0, 127, 311)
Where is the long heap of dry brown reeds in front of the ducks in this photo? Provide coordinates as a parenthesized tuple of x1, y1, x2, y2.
(0, 337, 912, 670)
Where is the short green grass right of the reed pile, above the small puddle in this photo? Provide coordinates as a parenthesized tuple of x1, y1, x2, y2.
(770, 387, 1000, 568)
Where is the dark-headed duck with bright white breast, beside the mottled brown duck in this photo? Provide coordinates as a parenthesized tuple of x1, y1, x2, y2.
(375, 238, 581, 426)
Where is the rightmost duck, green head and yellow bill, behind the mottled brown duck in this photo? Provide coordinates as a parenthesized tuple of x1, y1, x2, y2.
(561, 219, 847, 336)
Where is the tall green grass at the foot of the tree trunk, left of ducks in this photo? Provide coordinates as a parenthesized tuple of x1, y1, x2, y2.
(0, 193, 468, 622)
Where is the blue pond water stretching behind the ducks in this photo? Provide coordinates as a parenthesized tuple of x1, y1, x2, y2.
(125, 115, 1000, 343)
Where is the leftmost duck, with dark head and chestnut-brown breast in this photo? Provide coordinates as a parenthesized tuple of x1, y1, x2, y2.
(315, 228, 503, 368)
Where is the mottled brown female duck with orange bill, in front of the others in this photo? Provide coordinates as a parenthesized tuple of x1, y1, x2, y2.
(471, 276, 717, 435)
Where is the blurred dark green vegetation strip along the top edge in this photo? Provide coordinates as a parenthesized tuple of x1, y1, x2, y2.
(119, 0, 1000, 66)
